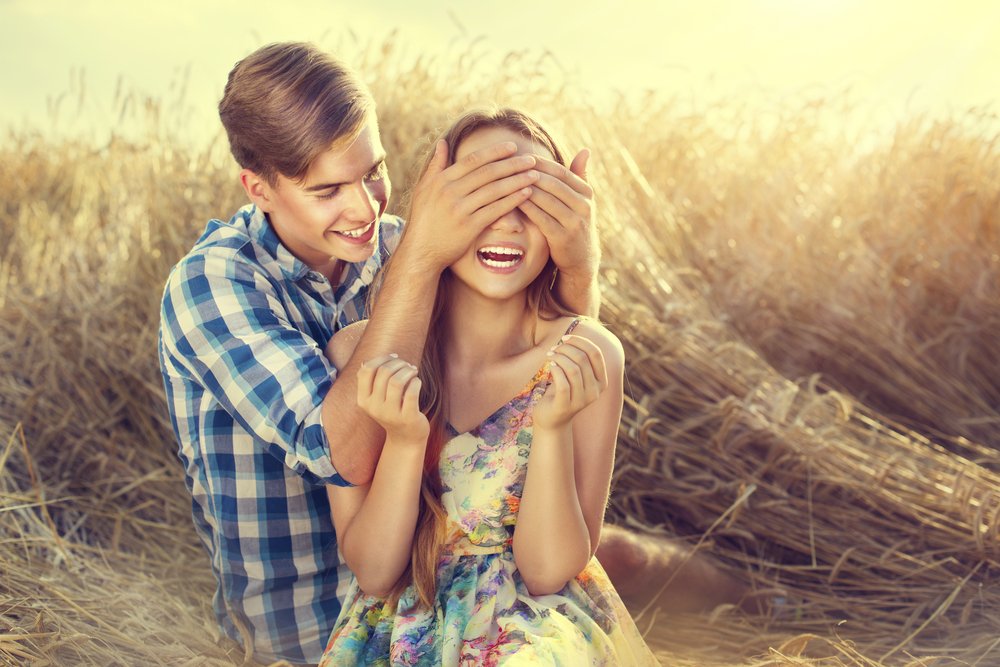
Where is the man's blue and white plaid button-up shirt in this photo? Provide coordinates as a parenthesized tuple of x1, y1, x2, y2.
(159, 206, 402, 663)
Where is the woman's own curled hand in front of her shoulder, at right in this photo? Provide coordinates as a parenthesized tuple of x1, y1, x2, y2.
(534, 334, 608, 429)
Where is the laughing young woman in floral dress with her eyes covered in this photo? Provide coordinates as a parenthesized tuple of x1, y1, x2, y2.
(321, 109, 657, 667)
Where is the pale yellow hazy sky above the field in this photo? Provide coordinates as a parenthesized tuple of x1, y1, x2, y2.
(0, 0, 1000, 142)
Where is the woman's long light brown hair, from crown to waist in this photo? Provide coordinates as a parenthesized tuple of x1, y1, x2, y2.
(376, 108, 573, 607)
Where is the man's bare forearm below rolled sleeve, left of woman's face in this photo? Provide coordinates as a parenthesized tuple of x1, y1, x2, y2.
(323, 244, 440, 484)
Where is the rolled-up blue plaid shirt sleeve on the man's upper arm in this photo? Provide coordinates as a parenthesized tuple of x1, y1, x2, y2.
(162, 247, 347, 485)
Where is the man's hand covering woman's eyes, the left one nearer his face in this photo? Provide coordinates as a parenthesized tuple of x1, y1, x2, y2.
(400, 141, 540, 271)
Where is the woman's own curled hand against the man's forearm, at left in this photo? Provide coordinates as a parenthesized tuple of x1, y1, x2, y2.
(358, 355, 430, 444)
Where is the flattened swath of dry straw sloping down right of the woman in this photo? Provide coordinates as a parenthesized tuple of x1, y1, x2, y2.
(600, 298, 1000, 661)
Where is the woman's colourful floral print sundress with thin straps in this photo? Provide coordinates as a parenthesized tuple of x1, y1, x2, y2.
(320, 322, 659, 667)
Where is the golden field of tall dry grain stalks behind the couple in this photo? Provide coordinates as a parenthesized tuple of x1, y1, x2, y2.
(0, 3, 1000, 667)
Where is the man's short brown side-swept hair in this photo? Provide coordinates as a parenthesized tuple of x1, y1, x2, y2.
(219, 42, 375, 185)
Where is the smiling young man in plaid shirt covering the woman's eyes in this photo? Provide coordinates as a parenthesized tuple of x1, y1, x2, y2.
(159, 44, 599, 664)
